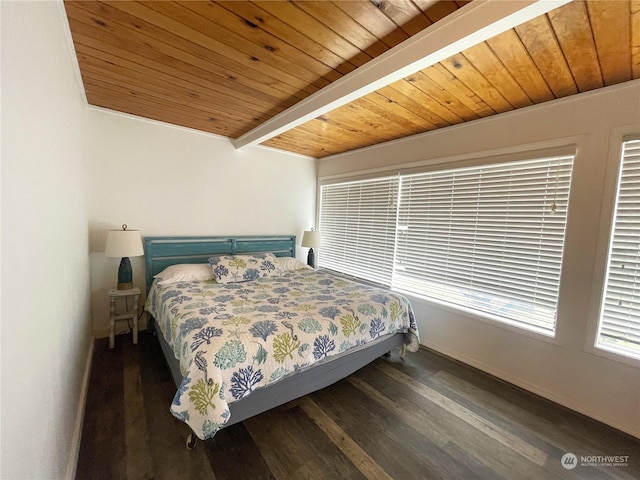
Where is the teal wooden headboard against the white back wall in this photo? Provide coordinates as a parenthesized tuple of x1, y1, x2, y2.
(144, 235, 296, 292)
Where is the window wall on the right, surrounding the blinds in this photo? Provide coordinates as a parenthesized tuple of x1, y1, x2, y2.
(318, 81, 640, 437)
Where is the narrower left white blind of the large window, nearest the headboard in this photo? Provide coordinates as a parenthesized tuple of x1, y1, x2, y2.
(318, 177, 398, 286)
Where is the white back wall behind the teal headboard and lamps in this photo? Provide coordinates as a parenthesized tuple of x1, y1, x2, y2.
(88, 109, 316, 337)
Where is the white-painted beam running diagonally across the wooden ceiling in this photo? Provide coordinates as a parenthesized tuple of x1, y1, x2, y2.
(231, 0, 571, 149)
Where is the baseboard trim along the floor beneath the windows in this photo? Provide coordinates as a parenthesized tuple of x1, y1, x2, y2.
(420, 340, 640, 438)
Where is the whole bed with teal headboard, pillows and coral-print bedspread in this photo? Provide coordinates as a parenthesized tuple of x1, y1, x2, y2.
(145, 235, 418, 446)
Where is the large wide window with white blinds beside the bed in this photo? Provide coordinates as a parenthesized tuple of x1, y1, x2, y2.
(319, 156, 573, 334)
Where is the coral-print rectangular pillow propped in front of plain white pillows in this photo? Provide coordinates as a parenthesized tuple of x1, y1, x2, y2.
(209, 253, 277, 283)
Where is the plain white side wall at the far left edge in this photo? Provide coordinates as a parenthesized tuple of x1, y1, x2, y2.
(0, 1, 92, 480)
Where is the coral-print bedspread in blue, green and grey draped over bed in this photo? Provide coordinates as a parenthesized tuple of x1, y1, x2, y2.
(146, 270, 418, 439)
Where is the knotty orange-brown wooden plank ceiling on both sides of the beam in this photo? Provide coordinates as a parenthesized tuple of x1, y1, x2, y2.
(65, 0, 640, 158)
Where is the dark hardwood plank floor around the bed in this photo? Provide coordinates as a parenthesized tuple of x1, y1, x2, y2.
(76, 333, 640, 480)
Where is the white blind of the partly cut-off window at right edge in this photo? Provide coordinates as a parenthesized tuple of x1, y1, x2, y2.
(597, 139, 640, 358)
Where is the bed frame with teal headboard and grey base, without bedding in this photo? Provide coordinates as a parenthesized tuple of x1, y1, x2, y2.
(145, 235, 404, 442)
